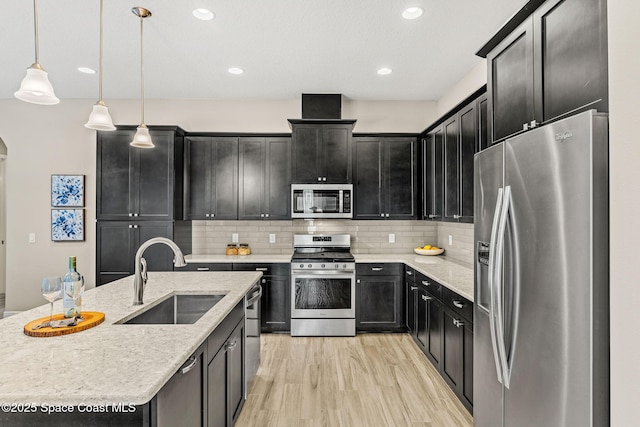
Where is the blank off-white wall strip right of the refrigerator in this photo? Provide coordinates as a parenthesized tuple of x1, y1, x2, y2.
(608, 0, 640, 427)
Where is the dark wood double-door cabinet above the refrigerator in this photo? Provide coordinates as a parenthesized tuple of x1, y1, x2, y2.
(477, 0, 608, 142)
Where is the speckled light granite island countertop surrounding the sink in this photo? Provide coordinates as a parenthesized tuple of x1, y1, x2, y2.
(0, 272, 262, 405)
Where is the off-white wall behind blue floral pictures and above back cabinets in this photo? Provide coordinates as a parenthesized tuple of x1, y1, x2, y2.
(0, 99, 436, 311)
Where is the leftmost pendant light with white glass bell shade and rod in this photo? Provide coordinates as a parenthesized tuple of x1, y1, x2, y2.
(14, 0, 60, 105)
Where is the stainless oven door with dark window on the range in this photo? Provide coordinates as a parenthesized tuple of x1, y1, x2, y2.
(291, 270, 356, 319)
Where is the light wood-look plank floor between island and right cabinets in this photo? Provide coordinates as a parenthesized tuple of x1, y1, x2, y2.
(236, 334, 473, 427)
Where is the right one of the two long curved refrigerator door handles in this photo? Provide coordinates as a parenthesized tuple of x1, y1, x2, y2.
(494, 185, 511, 388)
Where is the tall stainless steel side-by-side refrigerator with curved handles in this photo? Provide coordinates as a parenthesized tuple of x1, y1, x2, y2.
(473, 110, 609, 427)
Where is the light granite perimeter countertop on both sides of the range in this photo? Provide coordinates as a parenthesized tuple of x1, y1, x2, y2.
(186, 253, 473, 302)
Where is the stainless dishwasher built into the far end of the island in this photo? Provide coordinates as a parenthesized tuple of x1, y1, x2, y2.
(244, 279, 266, 399)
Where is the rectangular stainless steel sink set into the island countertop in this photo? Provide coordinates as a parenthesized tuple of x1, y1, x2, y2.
(116, 294, 224, 325)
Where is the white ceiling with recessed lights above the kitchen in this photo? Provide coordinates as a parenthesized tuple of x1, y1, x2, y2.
(0, 0, 524, 103)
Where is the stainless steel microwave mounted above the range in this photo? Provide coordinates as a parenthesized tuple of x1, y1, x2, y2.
(291, 184, 353, 218)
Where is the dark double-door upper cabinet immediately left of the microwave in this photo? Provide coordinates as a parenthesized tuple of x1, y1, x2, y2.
(238, 137, 291, 219)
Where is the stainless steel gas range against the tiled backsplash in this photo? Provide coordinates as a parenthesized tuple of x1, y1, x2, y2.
(291, 234, 356, 337)
